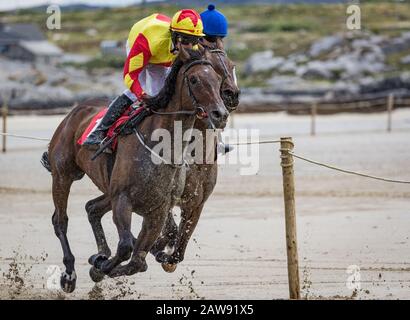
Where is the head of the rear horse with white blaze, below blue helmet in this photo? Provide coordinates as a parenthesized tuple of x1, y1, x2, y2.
(201, 37, 240, 112)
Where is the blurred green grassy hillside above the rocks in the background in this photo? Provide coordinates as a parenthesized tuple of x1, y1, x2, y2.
(0, 0, 410, 82)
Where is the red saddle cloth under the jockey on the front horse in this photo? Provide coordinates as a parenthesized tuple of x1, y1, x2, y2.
(77, 106, 144, 151)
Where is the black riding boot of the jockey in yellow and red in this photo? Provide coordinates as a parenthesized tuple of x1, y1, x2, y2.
(83, 94, 133, 148)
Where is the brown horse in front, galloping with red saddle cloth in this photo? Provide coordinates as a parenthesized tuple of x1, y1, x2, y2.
(44, 48, 228, 292)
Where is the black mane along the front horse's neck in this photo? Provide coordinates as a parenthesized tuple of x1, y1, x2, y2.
(145, 49, 203, 110)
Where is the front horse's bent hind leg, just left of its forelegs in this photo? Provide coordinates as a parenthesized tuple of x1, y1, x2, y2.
(85, 195, 111, 258)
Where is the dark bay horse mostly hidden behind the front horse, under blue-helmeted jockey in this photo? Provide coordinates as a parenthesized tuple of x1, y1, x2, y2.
(151, 39, 240, 272)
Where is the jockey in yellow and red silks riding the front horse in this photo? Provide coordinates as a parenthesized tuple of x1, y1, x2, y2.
(83, 9, 204, 147)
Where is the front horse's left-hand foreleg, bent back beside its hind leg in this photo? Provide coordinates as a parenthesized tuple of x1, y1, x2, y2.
(93, 194, 134, 274)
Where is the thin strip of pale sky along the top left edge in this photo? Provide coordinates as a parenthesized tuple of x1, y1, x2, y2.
(0, 0, 157, 11)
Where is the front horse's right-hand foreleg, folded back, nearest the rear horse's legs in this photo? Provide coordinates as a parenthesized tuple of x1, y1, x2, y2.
(109, 209, 167, 277)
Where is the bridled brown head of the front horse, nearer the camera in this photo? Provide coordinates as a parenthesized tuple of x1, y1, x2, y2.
(177, 48, 229, 129)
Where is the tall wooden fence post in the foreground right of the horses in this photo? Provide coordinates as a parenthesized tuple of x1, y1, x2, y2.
(280, 137, 300, 299)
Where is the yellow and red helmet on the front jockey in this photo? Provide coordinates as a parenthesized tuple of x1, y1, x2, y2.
(171, 9, 205, 37)
